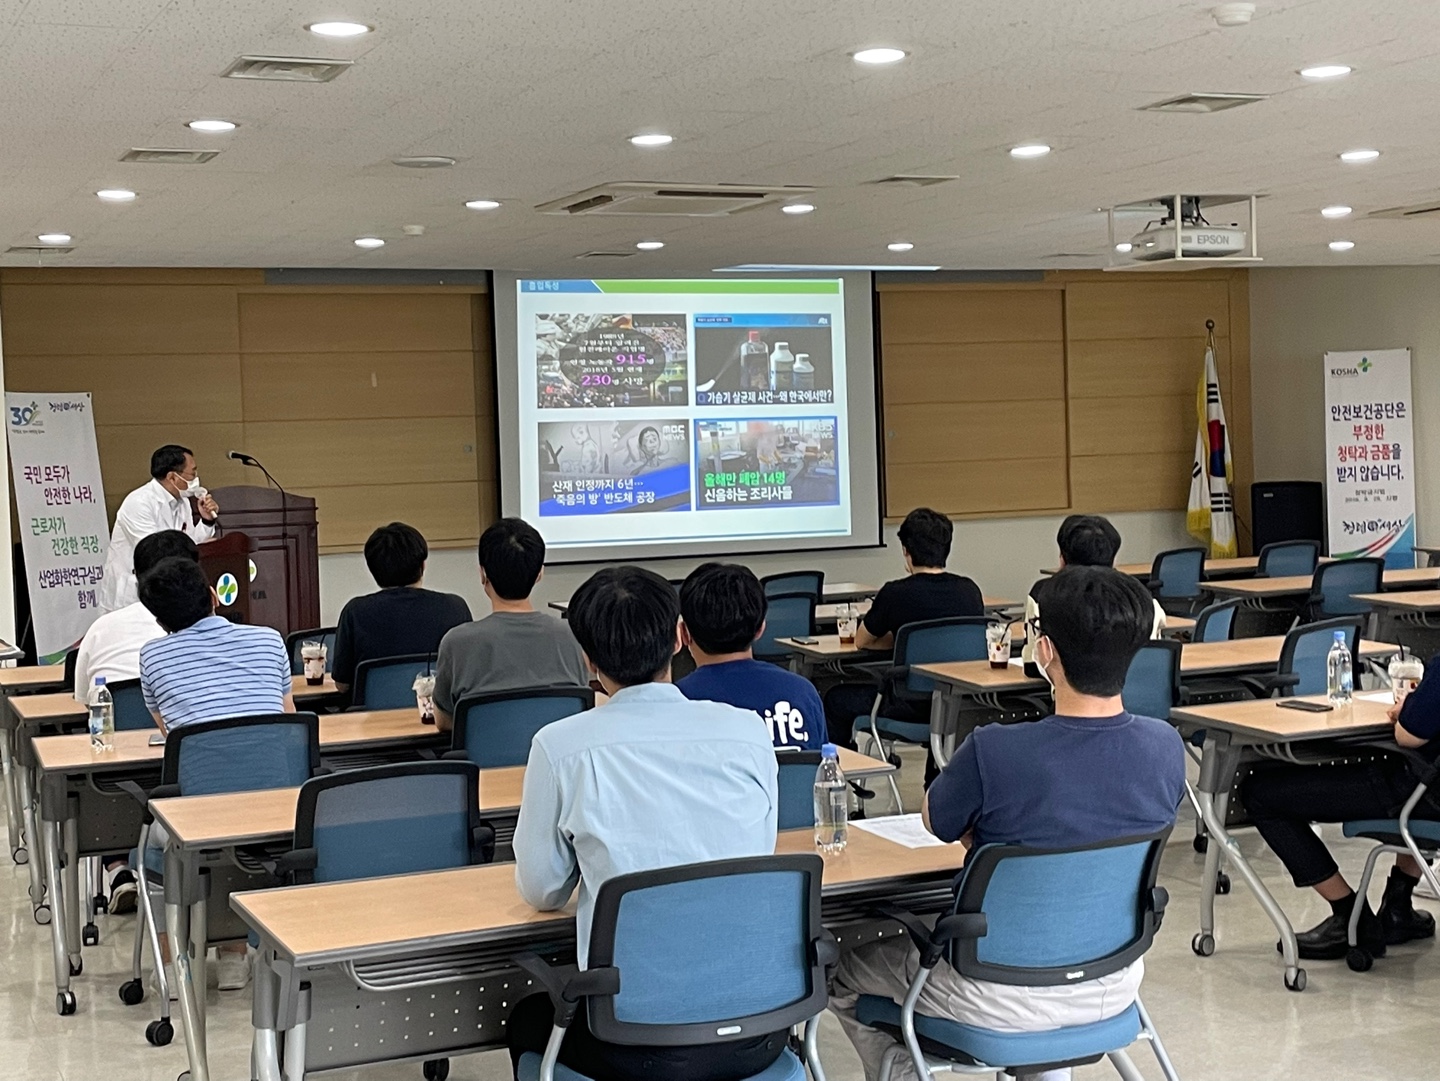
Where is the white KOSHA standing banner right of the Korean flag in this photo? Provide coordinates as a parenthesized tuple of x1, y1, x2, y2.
(1325, 350, 1416, 567)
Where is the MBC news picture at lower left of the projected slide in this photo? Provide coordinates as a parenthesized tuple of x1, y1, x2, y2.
(539, 419, 690, 518)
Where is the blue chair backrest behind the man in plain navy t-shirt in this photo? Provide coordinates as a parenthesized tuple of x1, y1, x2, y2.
(950, 828, 1169, 986)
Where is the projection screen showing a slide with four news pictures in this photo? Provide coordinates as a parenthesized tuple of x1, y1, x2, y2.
(494, 275, 880, 561)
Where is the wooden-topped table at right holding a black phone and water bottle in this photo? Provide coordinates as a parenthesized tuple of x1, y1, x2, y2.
(1171, 694, 1394, 990)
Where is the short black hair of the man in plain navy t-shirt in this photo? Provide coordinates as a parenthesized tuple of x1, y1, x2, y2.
(1040, 566, 1155, 698)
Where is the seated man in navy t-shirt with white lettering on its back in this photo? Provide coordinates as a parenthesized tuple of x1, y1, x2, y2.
(675, 563, 825, 751)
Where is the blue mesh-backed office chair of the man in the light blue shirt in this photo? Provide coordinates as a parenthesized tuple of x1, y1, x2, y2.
(516, 855, 840, 1081)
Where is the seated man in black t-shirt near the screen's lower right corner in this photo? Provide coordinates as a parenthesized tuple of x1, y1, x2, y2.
(825, 507, 985, 754)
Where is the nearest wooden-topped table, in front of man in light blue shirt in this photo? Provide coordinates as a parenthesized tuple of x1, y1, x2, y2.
(230, 829, 965, 1081)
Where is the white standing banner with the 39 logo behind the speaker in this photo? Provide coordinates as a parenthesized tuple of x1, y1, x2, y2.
(4, 393, 109, 664)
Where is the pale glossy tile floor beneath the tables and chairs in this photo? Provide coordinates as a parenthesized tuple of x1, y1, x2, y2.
(0, 759, 1440, 1081)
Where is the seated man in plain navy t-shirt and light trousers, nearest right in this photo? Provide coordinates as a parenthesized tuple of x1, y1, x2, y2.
(831, 567, 1185, 1081)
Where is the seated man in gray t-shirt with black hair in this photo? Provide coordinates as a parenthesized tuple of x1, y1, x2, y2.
(435, 518, 590, 731)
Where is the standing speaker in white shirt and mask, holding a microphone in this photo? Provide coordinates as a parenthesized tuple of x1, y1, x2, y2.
(99, 443, 220, 612)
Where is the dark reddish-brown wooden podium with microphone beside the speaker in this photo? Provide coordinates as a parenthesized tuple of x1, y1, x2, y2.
(200, 485, 320, 635)
